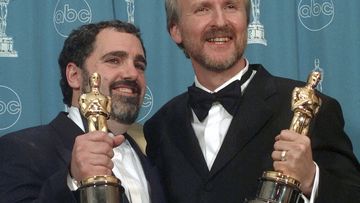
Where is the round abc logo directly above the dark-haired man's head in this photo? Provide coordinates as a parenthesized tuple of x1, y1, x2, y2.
(53, 0, 92, 37)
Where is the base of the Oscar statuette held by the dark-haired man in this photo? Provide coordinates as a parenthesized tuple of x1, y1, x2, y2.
(79, 175, 123, 203)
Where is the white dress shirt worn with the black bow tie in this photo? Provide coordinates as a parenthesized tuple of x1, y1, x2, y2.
(191, 60, 319, 203)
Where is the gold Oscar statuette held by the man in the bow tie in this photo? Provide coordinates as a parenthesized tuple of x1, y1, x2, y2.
(245, 71, 321, 203)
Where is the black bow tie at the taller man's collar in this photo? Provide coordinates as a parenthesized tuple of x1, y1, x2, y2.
(188, 69, 252, 121)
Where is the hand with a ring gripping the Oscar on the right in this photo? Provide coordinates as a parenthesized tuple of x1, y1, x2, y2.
(271, 130, 316, 196)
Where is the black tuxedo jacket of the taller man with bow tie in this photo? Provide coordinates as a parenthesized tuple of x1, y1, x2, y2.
(144, 65, 360, 203)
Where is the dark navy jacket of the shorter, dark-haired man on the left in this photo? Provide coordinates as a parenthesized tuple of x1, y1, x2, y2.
(0, 112, 164, 203)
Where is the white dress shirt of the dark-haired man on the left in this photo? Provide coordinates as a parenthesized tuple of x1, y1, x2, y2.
(67, 107, 151, 203)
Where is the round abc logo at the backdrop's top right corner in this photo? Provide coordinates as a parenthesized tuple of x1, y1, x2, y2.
(298, 0, 335, 31)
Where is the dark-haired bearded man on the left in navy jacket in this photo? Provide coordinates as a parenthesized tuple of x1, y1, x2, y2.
(0, 20, 164, 203)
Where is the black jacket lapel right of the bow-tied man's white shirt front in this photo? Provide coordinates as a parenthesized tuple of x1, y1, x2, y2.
(210, 66, 276, 176)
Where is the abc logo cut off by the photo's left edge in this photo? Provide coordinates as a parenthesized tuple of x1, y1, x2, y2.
(0, 85, 21, 130)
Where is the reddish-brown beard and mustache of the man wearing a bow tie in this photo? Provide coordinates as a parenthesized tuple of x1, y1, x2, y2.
(183, 26, 247, 73)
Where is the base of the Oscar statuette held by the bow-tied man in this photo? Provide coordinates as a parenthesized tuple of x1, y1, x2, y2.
(245, 171, 301, 203)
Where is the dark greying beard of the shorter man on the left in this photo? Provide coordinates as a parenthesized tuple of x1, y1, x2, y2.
(81, 68, 141, 124)
